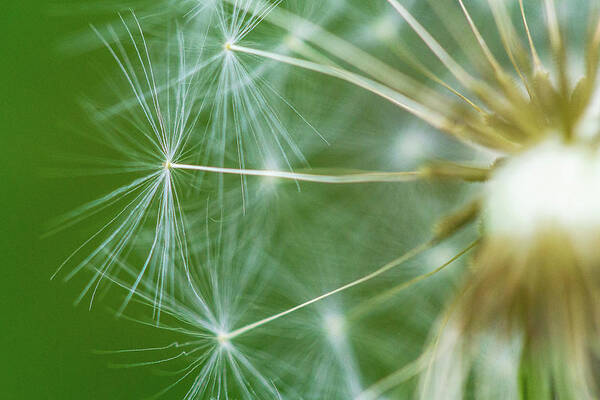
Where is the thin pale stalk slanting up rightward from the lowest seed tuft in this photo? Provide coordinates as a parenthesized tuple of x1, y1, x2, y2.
(223, 240, 436, 340)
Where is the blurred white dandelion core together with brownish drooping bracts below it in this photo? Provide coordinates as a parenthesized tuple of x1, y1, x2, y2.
(422, 138, 600, 399)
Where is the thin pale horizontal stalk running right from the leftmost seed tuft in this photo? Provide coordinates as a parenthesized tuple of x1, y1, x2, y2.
(169, 164, 422, 184)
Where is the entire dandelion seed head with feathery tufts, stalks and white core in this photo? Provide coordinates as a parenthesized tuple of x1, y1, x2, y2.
(56, 0, 600, 400)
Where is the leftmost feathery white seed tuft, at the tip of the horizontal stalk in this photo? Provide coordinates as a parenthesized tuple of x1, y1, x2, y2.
(53, 14, 203, 315)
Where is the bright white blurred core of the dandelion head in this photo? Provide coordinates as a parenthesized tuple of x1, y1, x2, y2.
(485, 140, 600, 238)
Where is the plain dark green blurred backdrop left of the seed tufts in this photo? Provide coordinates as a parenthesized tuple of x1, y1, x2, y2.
(0, 0, 173, 400)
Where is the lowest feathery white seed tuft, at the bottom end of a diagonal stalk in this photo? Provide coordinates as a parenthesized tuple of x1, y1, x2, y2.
(99, 219, 290, 399)
